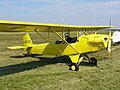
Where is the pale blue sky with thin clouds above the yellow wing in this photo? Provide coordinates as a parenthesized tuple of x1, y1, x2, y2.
(0, 0, 120, 27)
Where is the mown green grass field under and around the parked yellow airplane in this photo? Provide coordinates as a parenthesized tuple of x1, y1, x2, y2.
(0, 32, 120, 90)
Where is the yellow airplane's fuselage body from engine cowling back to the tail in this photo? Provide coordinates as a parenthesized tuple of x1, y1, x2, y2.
(30, 34, 108, 55)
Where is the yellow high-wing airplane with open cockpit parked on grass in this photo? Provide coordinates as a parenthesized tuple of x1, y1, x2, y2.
(0, 20, 114, 71)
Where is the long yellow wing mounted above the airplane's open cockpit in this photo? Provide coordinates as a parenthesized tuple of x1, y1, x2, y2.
(0, 20, 114, 32)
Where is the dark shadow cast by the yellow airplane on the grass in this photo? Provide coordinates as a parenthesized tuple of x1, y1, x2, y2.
(0, 55, 94, 77)
